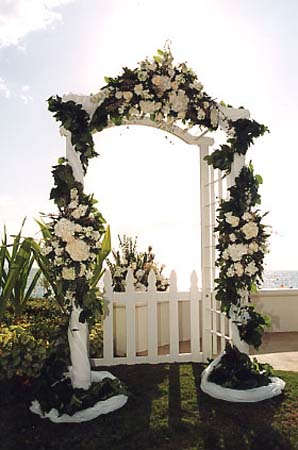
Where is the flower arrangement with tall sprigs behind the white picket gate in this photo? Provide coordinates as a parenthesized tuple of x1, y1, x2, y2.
(107, 235, 169, 292)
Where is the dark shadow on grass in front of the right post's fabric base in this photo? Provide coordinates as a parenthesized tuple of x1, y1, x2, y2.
(193, 364, 296, 450)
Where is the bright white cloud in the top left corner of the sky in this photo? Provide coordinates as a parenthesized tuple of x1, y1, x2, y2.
(0, 0, 74, 47)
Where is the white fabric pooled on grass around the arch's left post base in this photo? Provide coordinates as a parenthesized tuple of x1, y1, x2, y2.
(29, 371, 128, 423)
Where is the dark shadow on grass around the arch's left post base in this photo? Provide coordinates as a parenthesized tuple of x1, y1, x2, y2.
(0, 365, 168, 450)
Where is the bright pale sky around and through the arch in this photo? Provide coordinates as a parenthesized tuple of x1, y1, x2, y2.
(0, 0, 298, 286)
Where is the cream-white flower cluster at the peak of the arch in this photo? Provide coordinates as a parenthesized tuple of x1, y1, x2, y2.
(91, 50, 219, 129)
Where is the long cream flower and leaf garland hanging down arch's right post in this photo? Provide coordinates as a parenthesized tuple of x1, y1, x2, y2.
(215, 164, 270, 348)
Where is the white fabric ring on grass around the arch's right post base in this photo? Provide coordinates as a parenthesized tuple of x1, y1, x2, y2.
(201, 353, 286, 403)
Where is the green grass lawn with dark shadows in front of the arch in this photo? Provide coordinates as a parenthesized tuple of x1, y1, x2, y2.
(0, 364, 298, 450)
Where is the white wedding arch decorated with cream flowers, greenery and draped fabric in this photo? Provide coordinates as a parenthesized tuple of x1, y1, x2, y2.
(30, 49, 284, 422)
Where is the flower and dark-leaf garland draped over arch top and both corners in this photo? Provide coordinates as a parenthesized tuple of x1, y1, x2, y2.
(48, 44, 268, 172)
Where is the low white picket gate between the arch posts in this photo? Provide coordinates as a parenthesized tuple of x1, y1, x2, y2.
(92, 270, 203, 366)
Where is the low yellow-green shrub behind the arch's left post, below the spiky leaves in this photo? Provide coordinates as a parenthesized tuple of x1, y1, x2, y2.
(0, 299, 102, 380)
